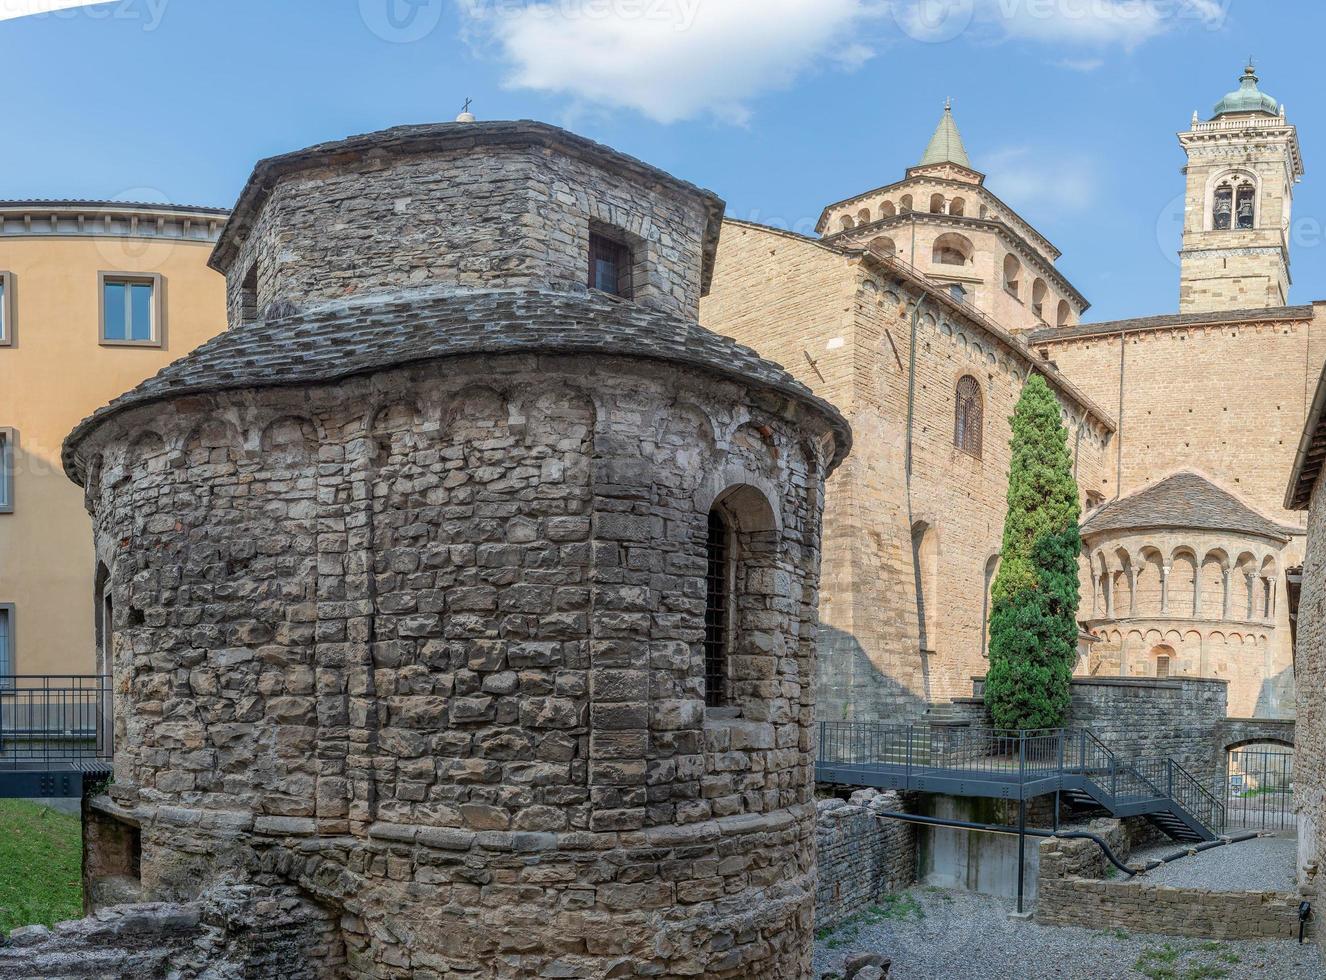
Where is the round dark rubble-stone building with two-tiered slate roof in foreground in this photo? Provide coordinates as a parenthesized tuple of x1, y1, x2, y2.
(64, 122, 850, 980)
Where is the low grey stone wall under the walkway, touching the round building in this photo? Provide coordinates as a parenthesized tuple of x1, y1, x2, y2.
(815, 789, 916, 931)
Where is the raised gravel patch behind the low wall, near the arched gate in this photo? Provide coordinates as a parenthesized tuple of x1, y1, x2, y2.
(1127, 837, 1298, 891)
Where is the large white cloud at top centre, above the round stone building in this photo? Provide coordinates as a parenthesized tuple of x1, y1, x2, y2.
(461, 0, 886, 123)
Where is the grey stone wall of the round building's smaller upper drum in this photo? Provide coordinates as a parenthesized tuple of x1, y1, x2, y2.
(228, 123, 709, 324)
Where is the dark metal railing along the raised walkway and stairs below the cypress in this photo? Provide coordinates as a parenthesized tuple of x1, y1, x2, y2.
(817, 721, 1227, 833)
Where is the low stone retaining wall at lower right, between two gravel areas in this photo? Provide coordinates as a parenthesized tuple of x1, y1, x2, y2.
(1036, 821, 1298, 939)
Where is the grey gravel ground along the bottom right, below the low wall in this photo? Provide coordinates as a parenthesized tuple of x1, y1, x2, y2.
(815, 891, 1326, 980)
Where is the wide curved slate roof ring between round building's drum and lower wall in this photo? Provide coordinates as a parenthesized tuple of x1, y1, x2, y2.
(64, 290, 851, 483)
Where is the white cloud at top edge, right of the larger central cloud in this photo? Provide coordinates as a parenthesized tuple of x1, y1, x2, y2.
(894, 0, 1232, 49)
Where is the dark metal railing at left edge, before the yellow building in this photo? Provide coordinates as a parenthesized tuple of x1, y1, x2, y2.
(0, 675, 111, 769)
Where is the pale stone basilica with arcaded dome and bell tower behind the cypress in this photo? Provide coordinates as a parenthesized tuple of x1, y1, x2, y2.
(701, 68, 1310, 719)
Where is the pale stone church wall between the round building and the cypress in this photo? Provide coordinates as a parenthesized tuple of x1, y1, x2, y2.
(701, 221, 1109, 720)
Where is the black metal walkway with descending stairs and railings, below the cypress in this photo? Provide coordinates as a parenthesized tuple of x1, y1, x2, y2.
(815, 721, 1225, 842)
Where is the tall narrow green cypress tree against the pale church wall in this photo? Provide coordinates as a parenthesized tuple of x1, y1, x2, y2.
(985, 374, 1082, 729)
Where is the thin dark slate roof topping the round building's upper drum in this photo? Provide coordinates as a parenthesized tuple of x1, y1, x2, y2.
(210, 119, 727, 293)
